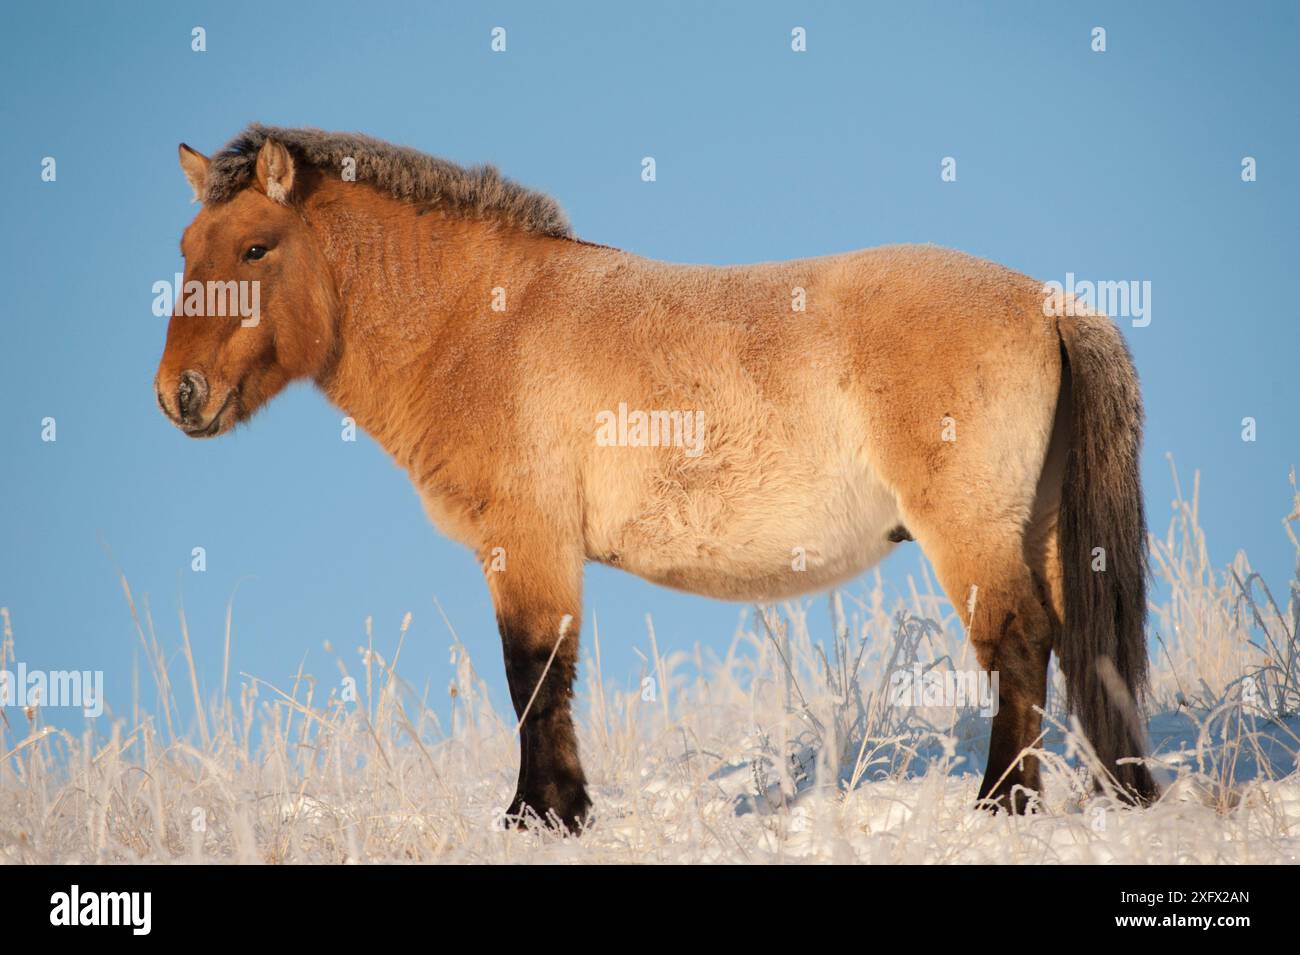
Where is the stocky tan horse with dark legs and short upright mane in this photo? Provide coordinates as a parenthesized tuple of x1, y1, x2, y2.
(155, 126, 1157, 826)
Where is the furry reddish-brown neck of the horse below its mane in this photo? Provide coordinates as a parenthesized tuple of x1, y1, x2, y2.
(304, 182, 575, 468)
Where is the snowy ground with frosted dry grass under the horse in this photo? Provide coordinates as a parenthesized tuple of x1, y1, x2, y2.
(0, 470, 1300, 864)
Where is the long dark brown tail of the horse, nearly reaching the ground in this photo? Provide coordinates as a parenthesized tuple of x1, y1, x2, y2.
(1056, 316, 1160, 804)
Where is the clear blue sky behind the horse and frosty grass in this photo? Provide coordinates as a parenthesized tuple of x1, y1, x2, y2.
(0, 0, 1300, 722)
